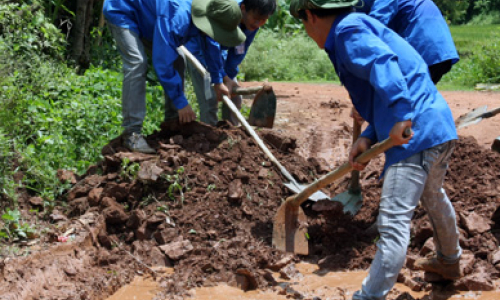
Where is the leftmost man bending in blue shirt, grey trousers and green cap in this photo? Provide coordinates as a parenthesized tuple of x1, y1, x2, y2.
(103, 0, 245, 153)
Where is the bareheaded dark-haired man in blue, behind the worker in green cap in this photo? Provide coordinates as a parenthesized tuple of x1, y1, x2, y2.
(186, 0, 276, 125)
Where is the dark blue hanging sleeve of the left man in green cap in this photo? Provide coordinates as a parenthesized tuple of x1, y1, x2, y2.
(152, 17, 188, 109)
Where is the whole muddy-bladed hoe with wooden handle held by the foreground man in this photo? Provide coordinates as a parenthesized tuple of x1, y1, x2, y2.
(273, 128, 411, 255)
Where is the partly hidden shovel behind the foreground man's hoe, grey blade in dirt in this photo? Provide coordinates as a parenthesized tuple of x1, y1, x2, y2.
(332, 118, 363, 216)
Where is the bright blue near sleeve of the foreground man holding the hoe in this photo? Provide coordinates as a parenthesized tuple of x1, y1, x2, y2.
(337, 26, 413, 122)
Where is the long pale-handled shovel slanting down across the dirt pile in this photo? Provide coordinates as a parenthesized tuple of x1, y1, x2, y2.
(179, 46, 330, 201)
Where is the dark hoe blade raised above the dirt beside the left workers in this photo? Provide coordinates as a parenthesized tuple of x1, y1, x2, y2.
(248, 86, 276, 128)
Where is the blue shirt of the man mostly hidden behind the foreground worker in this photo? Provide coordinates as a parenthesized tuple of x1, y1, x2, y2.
(355, 0, 459, 66)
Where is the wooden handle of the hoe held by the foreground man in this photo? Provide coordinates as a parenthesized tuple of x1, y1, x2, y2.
(286, 128, 411, 206)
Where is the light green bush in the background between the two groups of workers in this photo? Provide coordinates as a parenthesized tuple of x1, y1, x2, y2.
(240, 30, 337, 81)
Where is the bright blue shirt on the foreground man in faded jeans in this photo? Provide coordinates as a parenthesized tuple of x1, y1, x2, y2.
(325, 13, 457, 175)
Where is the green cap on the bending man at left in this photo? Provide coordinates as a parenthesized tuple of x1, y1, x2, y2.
(191, 0, 246, 47)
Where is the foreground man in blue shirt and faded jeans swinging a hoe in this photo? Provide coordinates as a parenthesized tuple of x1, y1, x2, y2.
(290, 0, 462, 300)
